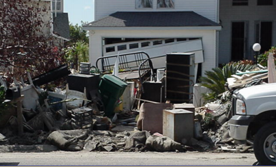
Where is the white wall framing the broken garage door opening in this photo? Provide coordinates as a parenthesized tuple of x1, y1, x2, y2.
(89, 30, 217, 73)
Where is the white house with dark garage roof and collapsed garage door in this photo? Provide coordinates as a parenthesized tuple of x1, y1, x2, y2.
(83, 0, 221, 74)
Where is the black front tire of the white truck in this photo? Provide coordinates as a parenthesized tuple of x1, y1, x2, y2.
(254, 122, 276, 165)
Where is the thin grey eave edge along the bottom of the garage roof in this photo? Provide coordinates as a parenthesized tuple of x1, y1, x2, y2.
(82, 26, 222, 31)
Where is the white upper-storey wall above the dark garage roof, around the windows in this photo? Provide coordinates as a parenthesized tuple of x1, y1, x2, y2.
(94, 0, 218, 22)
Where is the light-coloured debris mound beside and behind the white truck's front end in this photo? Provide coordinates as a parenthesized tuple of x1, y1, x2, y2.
(195, 65, 269, 152)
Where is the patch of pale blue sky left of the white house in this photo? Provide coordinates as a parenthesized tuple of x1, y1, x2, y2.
(63, 0, 94, 25)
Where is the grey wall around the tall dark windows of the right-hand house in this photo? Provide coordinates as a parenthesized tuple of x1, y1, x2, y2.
(219, 0, 276, 63)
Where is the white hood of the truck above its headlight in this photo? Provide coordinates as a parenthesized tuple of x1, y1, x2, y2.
(238, 83, 276, 100)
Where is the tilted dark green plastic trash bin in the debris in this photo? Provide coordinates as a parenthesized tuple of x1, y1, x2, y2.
(99, 75, 127, 117)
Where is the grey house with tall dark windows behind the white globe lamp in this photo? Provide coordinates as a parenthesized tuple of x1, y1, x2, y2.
(219, 0, 276, 64)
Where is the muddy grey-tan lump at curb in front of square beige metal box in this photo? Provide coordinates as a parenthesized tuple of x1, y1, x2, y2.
(146, 135, 185, 152)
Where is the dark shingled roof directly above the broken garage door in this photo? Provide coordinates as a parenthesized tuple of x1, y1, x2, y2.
(84, 11, 220, 27)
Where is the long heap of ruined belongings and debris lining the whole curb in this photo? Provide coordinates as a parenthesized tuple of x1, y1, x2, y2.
(0, 54, 268, 155)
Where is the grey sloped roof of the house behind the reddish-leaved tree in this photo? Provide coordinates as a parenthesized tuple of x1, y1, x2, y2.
(53, 13, 70, 39)
